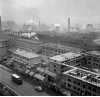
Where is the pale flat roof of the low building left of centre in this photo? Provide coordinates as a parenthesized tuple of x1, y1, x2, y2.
(13, 50, 40, 59)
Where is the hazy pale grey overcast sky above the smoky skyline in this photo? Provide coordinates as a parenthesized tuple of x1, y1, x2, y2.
(0, 0, 100, 24)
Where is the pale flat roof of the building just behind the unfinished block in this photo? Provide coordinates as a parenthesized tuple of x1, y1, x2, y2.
(50, 52, 81, 62)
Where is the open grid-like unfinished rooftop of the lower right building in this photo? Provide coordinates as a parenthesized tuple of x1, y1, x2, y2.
(63, 68, 100, 87)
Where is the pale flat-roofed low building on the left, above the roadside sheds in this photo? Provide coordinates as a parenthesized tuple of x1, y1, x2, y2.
(12, 50, 41, 70)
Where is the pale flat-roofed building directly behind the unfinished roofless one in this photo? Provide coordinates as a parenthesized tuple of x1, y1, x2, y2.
(49, 52, 84, 74)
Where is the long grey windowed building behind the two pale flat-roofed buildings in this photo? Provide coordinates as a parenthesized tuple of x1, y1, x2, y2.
(41, 43, 81, 57)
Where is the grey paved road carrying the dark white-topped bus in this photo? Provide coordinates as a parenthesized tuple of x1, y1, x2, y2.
(0, 65, 49, 96)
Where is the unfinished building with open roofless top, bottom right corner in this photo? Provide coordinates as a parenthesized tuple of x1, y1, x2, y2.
(63, 68, 100, 96)
